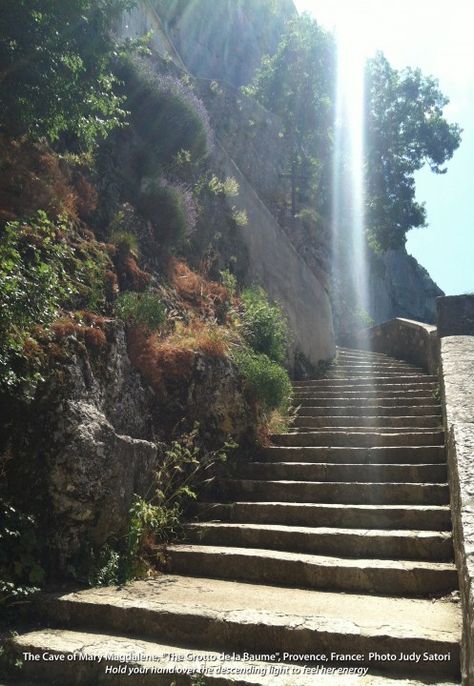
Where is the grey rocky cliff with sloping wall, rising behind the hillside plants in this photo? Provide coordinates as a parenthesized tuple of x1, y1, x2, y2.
(119, 0, 334, 372)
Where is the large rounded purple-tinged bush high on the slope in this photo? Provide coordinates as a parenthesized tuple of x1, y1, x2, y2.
(119, 60, 212, 168)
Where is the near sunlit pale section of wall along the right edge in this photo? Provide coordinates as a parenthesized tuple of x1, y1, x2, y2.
(440, 336, 474, 685)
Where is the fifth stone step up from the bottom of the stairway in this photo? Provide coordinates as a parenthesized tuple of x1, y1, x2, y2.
(193, 502, 451, 531)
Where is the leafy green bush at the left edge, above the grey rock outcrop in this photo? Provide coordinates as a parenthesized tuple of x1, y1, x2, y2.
(0, 211, 114, 397)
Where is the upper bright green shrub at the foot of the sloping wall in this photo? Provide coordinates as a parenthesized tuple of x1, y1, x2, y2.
(241, 286, 288, 363)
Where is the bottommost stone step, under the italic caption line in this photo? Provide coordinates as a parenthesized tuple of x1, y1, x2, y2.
(6, 629, 455, 686)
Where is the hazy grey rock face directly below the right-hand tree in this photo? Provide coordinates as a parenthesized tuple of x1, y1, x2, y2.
(369, 248, 444, 324)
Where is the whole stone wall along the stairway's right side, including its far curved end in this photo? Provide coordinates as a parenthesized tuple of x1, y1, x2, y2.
(347, 295, 474, 686)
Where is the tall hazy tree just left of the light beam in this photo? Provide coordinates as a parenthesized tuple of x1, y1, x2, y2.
(244, 13, 335, 218)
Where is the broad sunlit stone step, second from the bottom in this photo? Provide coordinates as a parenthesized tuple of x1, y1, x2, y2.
(32, 580, 460, 686)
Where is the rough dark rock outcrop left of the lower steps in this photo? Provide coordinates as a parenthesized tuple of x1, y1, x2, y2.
(4, 322, 255, 571)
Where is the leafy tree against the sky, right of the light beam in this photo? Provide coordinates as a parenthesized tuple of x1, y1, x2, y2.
(366, 53, 461, 252)
